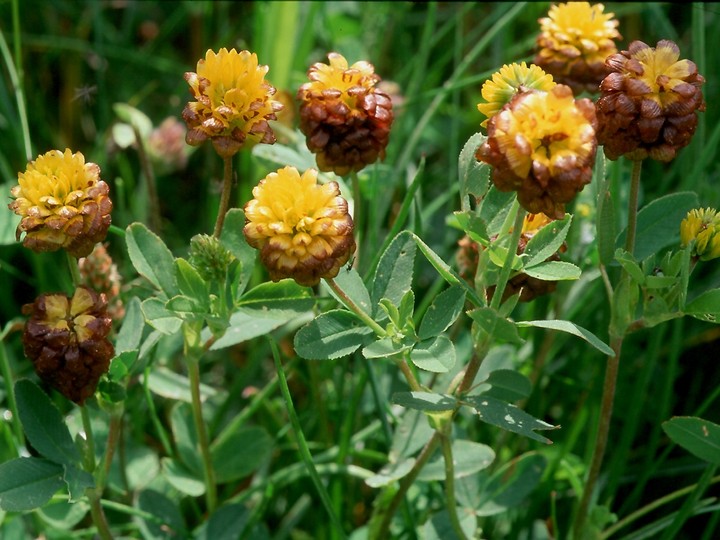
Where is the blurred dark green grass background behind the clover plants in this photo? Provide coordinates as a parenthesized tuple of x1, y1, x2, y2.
(0, 0, 720, 538)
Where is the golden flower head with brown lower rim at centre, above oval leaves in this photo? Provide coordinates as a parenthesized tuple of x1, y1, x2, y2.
(243, 167, 355, 286)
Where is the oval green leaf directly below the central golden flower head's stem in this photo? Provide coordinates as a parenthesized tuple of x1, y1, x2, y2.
(294, 309, 373, 360)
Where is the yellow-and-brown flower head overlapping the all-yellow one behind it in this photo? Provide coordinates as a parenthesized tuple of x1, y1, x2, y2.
(475, 84, 597, 219)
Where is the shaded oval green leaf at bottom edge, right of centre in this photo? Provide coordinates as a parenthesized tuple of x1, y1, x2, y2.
(475, 452, 547, 516)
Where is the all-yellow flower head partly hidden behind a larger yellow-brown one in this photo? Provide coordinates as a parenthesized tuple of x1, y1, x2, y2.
(478, 62, 556, 127)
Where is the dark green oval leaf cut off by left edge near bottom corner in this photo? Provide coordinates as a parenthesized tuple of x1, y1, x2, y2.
(0, 457, 64, 512)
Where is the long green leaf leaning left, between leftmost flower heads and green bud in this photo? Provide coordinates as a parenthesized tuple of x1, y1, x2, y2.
(125, 223, 178, 297)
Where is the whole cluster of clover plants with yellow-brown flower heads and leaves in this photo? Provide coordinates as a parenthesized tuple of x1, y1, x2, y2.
(0, 2, 720, 540)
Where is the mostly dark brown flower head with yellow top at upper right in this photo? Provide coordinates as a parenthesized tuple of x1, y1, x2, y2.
(597, 40, 705, 162)
